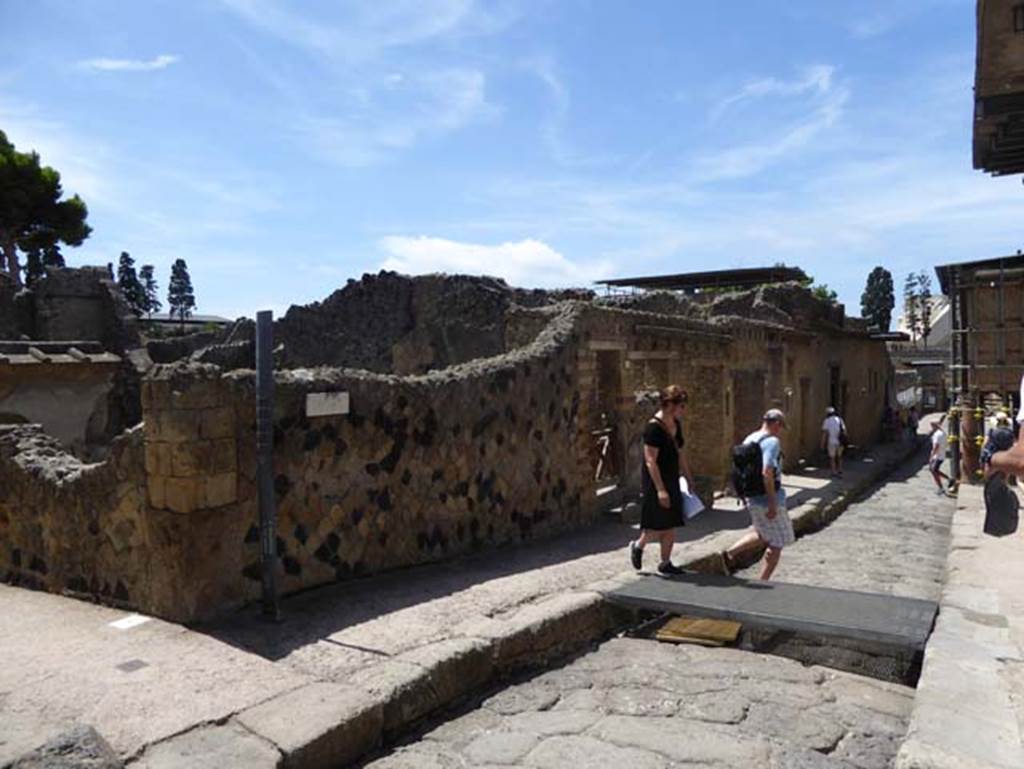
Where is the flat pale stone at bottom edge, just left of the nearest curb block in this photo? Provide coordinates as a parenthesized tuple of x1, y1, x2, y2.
(132, 723, 281, 769)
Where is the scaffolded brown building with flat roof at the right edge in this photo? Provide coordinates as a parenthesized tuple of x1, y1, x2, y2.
(936, 252, 1024, 480)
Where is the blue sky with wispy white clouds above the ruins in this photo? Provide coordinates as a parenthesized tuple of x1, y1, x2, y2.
(0, 0, 1024, 316)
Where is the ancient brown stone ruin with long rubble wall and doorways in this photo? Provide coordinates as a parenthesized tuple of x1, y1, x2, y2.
(0, 272, 892, 621)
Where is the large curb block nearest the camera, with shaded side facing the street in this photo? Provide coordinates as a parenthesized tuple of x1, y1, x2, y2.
(237, 683, 384, 769)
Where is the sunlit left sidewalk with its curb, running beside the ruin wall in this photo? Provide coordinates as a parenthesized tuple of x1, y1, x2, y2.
(0, 436, 923, 767)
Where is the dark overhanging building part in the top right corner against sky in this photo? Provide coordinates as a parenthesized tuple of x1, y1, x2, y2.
(974, 0, 1024, 176)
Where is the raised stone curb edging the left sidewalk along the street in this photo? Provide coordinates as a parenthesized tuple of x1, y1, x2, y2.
(132, 438, 919, 769)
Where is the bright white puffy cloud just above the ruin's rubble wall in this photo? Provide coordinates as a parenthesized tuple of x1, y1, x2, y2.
(379, 236, 611, 288)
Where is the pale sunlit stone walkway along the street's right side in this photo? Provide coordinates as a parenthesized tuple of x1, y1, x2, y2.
(895, 486, 1024, 769)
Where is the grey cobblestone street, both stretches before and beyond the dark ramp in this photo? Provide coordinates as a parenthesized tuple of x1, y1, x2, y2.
(368, 454, 953, 769)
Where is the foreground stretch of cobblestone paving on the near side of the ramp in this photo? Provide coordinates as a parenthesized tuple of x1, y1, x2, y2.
(367, 639, 913, 769)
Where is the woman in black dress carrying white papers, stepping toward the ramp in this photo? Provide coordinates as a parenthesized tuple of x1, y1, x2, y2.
(630, 385, 693, 574)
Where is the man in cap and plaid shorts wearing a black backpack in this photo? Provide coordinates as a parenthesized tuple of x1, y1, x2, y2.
(722, 409, 797, 580)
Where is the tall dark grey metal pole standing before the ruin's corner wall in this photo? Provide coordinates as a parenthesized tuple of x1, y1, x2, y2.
(256, 310, 281, 621)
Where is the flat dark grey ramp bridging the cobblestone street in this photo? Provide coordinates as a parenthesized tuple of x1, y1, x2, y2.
(605, 574, 938, 650)
